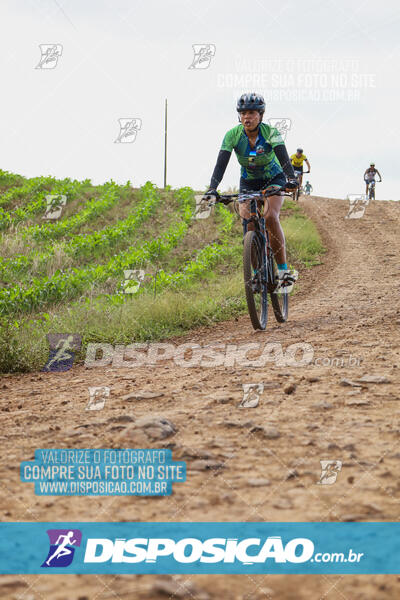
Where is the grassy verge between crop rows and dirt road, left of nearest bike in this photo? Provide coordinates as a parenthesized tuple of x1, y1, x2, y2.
(0, 271, 245, 372)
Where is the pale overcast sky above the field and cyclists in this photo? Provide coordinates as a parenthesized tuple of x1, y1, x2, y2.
(0, 0, 400, 200)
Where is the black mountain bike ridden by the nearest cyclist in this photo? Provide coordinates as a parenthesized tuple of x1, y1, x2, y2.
(206, 185, 292, 329)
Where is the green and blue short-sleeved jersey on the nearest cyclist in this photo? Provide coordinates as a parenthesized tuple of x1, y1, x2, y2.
(221, 123, 284, 179)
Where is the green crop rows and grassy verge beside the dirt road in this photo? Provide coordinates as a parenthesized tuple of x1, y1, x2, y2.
(0, 173, 323, 372)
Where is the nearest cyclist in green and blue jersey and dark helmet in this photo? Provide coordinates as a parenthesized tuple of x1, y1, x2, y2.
(206, 92, 297, 284)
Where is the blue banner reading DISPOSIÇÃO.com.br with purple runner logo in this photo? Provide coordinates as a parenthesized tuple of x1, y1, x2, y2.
(0, 522, 400, 575)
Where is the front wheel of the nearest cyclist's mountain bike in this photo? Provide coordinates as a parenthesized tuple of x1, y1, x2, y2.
(243, 231, 268, 329)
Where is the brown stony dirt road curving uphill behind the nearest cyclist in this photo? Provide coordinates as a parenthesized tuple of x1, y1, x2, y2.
(0, 197, 400, 600)
